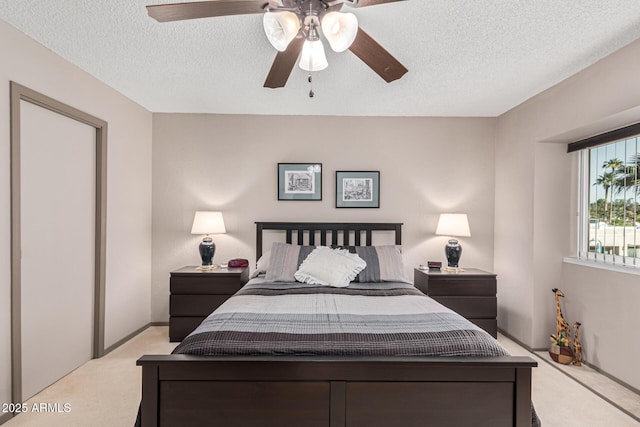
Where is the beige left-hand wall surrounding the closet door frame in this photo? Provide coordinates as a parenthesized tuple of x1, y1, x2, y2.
(0, 21, 151, 412)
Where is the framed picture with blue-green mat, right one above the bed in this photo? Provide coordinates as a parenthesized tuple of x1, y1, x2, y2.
(336, 171, 380, 208)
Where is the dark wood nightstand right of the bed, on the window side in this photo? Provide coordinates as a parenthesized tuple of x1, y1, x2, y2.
(413, 268, 498, 338)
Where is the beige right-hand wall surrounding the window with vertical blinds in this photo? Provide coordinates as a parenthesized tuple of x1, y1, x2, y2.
(494, 37, 640, 389)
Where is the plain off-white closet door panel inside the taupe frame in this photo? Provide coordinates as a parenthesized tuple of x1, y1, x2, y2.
(20, 101, 96, 401)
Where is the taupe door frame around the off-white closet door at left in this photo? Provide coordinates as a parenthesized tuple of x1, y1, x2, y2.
(10, 81, 107, 402)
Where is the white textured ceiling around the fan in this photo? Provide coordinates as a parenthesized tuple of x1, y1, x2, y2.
(0, 0, 640, 116)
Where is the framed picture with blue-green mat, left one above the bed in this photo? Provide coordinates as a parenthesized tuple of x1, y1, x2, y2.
(278, 163, 322, 200)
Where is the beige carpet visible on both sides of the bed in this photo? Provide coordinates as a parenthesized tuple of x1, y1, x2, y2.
(4, 327, 640, 427)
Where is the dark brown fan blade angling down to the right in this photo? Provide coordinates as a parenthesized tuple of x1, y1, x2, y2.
(349, 27, 409, 83)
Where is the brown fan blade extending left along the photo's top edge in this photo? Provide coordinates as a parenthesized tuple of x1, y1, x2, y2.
(147, 0, 269, 22)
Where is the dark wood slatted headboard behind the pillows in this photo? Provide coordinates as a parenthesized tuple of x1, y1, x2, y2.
(256, 222, 402, 261)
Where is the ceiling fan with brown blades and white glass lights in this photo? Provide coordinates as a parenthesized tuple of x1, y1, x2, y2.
(147, 0, 408, 89)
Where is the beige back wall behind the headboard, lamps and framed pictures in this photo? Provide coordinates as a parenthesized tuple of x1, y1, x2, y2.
(151, 114, 495, 321)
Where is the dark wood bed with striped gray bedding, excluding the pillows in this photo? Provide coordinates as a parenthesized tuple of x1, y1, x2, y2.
(137, 222, 538, 427)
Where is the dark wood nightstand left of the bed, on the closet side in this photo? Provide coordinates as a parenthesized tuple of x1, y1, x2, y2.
(169, 267, 249, 341)
